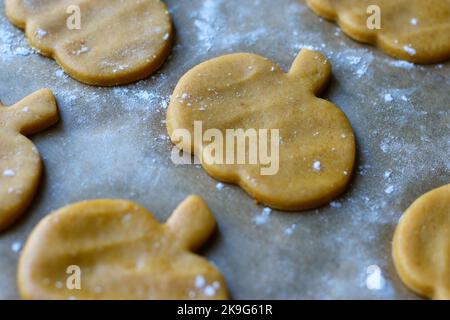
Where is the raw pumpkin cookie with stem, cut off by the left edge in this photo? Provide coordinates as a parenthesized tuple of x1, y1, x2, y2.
(0, 89, 59, 230)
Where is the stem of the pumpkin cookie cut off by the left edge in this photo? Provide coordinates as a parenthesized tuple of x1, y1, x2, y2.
(0, 89, 59, 135)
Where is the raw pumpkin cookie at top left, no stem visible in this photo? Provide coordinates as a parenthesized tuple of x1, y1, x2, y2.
(5, 0, 173, 86)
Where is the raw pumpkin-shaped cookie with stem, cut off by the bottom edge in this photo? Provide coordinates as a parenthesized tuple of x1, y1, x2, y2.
(18, 196, 228, 300)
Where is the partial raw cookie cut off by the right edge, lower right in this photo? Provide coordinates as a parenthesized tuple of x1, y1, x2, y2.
(393, 184, 450, 300)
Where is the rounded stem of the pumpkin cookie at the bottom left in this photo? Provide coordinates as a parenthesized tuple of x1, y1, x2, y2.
(166, 196, 216, 250)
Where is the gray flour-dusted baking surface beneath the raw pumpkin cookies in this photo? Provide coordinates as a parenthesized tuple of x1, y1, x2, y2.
(0, 0, 450, 299)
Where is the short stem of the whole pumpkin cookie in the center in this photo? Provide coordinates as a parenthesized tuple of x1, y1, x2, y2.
(288, 49, 331, 95)
